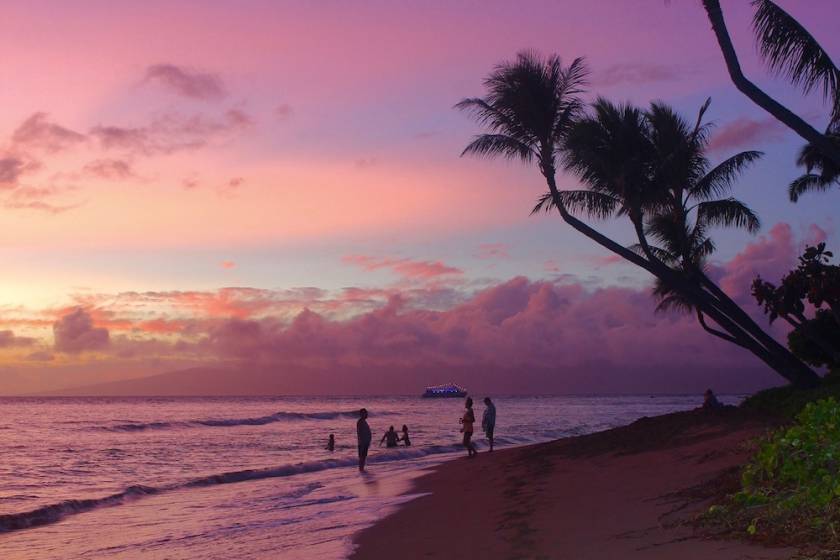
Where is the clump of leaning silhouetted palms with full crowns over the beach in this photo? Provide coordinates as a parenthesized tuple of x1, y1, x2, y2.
(456, 52, 818, 385)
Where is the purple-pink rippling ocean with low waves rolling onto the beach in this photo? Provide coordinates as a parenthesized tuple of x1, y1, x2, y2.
(0, 395, 740, 560)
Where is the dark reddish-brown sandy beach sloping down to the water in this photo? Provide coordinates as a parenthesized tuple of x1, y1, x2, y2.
(352, 409, 795, 560)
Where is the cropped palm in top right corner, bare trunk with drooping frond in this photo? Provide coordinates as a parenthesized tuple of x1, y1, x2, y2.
(703, 0, 840, 165)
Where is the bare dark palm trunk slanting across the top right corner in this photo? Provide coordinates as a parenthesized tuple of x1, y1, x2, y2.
(703, 0, 840, 165)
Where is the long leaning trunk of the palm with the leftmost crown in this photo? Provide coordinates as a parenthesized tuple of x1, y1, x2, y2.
(543, 173, 819, 387)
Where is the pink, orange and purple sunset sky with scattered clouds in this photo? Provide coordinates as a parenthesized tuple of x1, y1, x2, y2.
(0, 0, 840, 393)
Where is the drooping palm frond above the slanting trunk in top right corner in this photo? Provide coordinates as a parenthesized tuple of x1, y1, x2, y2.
(753, 0, 840, 119)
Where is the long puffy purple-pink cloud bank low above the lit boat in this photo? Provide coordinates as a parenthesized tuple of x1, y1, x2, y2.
(189, 277, 776, 390)
